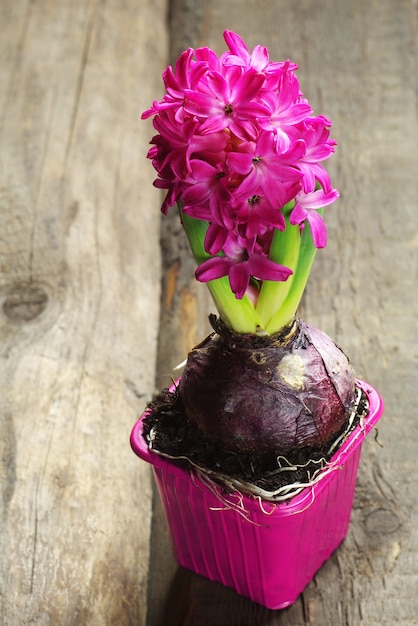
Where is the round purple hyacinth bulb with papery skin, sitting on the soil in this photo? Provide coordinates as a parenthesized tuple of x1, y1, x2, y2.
(179, 320, 355, 455)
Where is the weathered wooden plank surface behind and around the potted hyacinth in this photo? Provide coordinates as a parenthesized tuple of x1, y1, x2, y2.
(0, 0, 418, 626)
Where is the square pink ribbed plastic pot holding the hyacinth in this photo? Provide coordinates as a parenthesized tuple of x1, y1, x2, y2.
(131, 381, 383, 609)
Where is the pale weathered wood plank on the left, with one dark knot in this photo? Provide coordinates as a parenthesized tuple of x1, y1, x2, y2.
(0, 0, 167, 626)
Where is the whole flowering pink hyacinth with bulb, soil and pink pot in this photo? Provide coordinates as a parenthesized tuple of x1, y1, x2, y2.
(131, 31, 383, 608)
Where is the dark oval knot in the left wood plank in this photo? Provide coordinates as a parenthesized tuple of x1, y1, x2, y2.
(3, 283, 48, 322)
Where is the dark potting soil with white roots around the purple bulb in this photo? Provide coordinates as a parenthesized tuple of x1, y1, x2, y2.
(143, 382, 368, 492)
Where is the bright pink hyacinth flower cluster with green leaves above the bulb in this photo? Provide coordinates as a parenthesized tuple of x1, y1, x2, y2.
(142, 31, 339, 334)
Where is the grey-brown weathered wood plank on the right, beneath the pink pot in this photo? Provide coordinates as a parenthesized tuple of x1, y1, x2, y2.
(148, 0, 418, 626)
